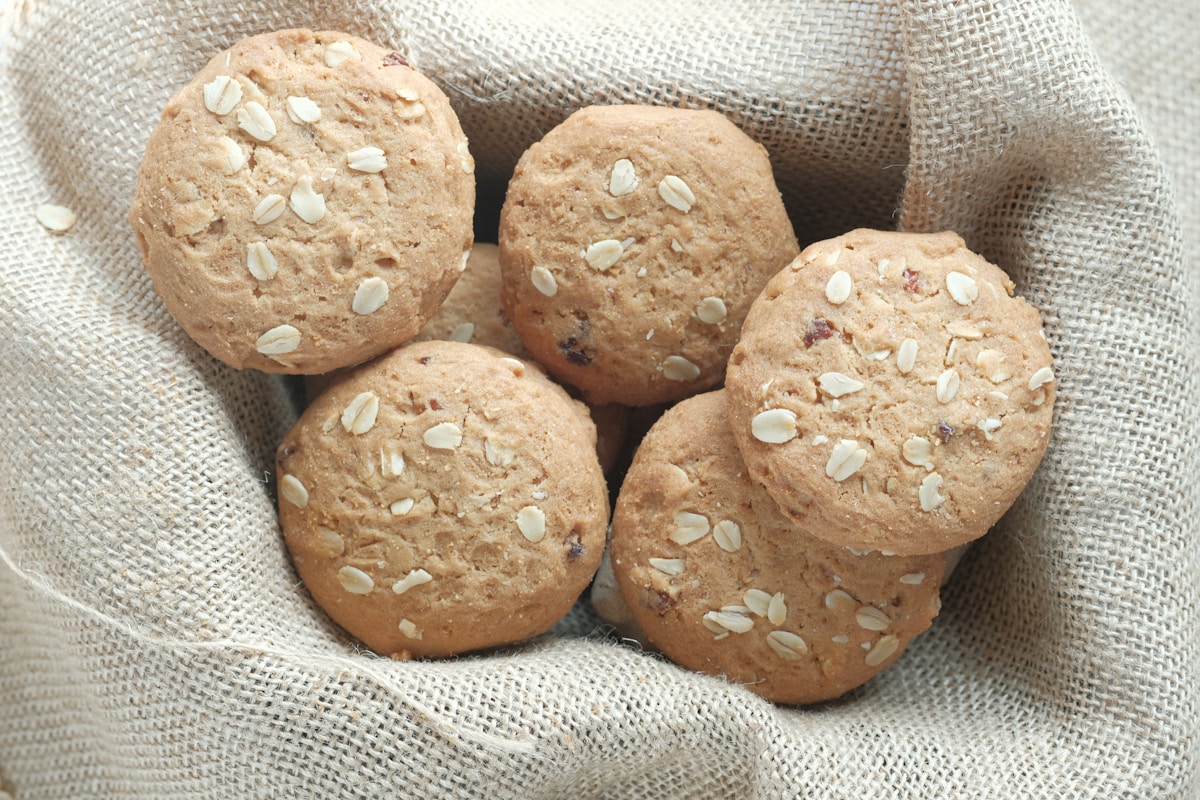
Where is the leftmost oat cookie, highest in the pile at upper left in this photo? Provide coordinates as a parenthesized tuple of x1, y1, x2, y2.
(130, 30, 475, 373)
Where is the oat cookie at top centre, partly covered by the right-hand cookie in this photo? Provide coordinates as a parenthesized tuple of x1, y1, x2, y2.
(499, 106, 799, 405)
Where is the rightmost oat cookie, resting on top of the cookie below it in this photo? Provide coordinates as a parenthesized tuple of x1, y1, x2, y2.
(726, 230, 1055, 555)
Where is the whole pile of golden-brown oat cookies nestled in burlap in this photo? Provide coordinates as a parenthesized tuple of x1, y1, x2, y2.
(130, 30, 1055, 703)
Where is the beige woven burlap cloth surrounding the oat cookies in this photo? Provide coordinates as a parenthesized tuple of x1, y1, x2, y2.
(0, 0, 1200, 800)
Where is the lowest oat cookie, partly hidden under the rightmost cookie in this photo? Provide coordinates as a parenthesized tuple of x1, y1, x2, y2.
(610, 391, 944, 703)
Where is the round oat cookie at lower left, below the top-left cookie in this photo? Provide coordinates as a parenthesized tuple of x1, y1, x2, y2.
(276, 342, 608, 657)
